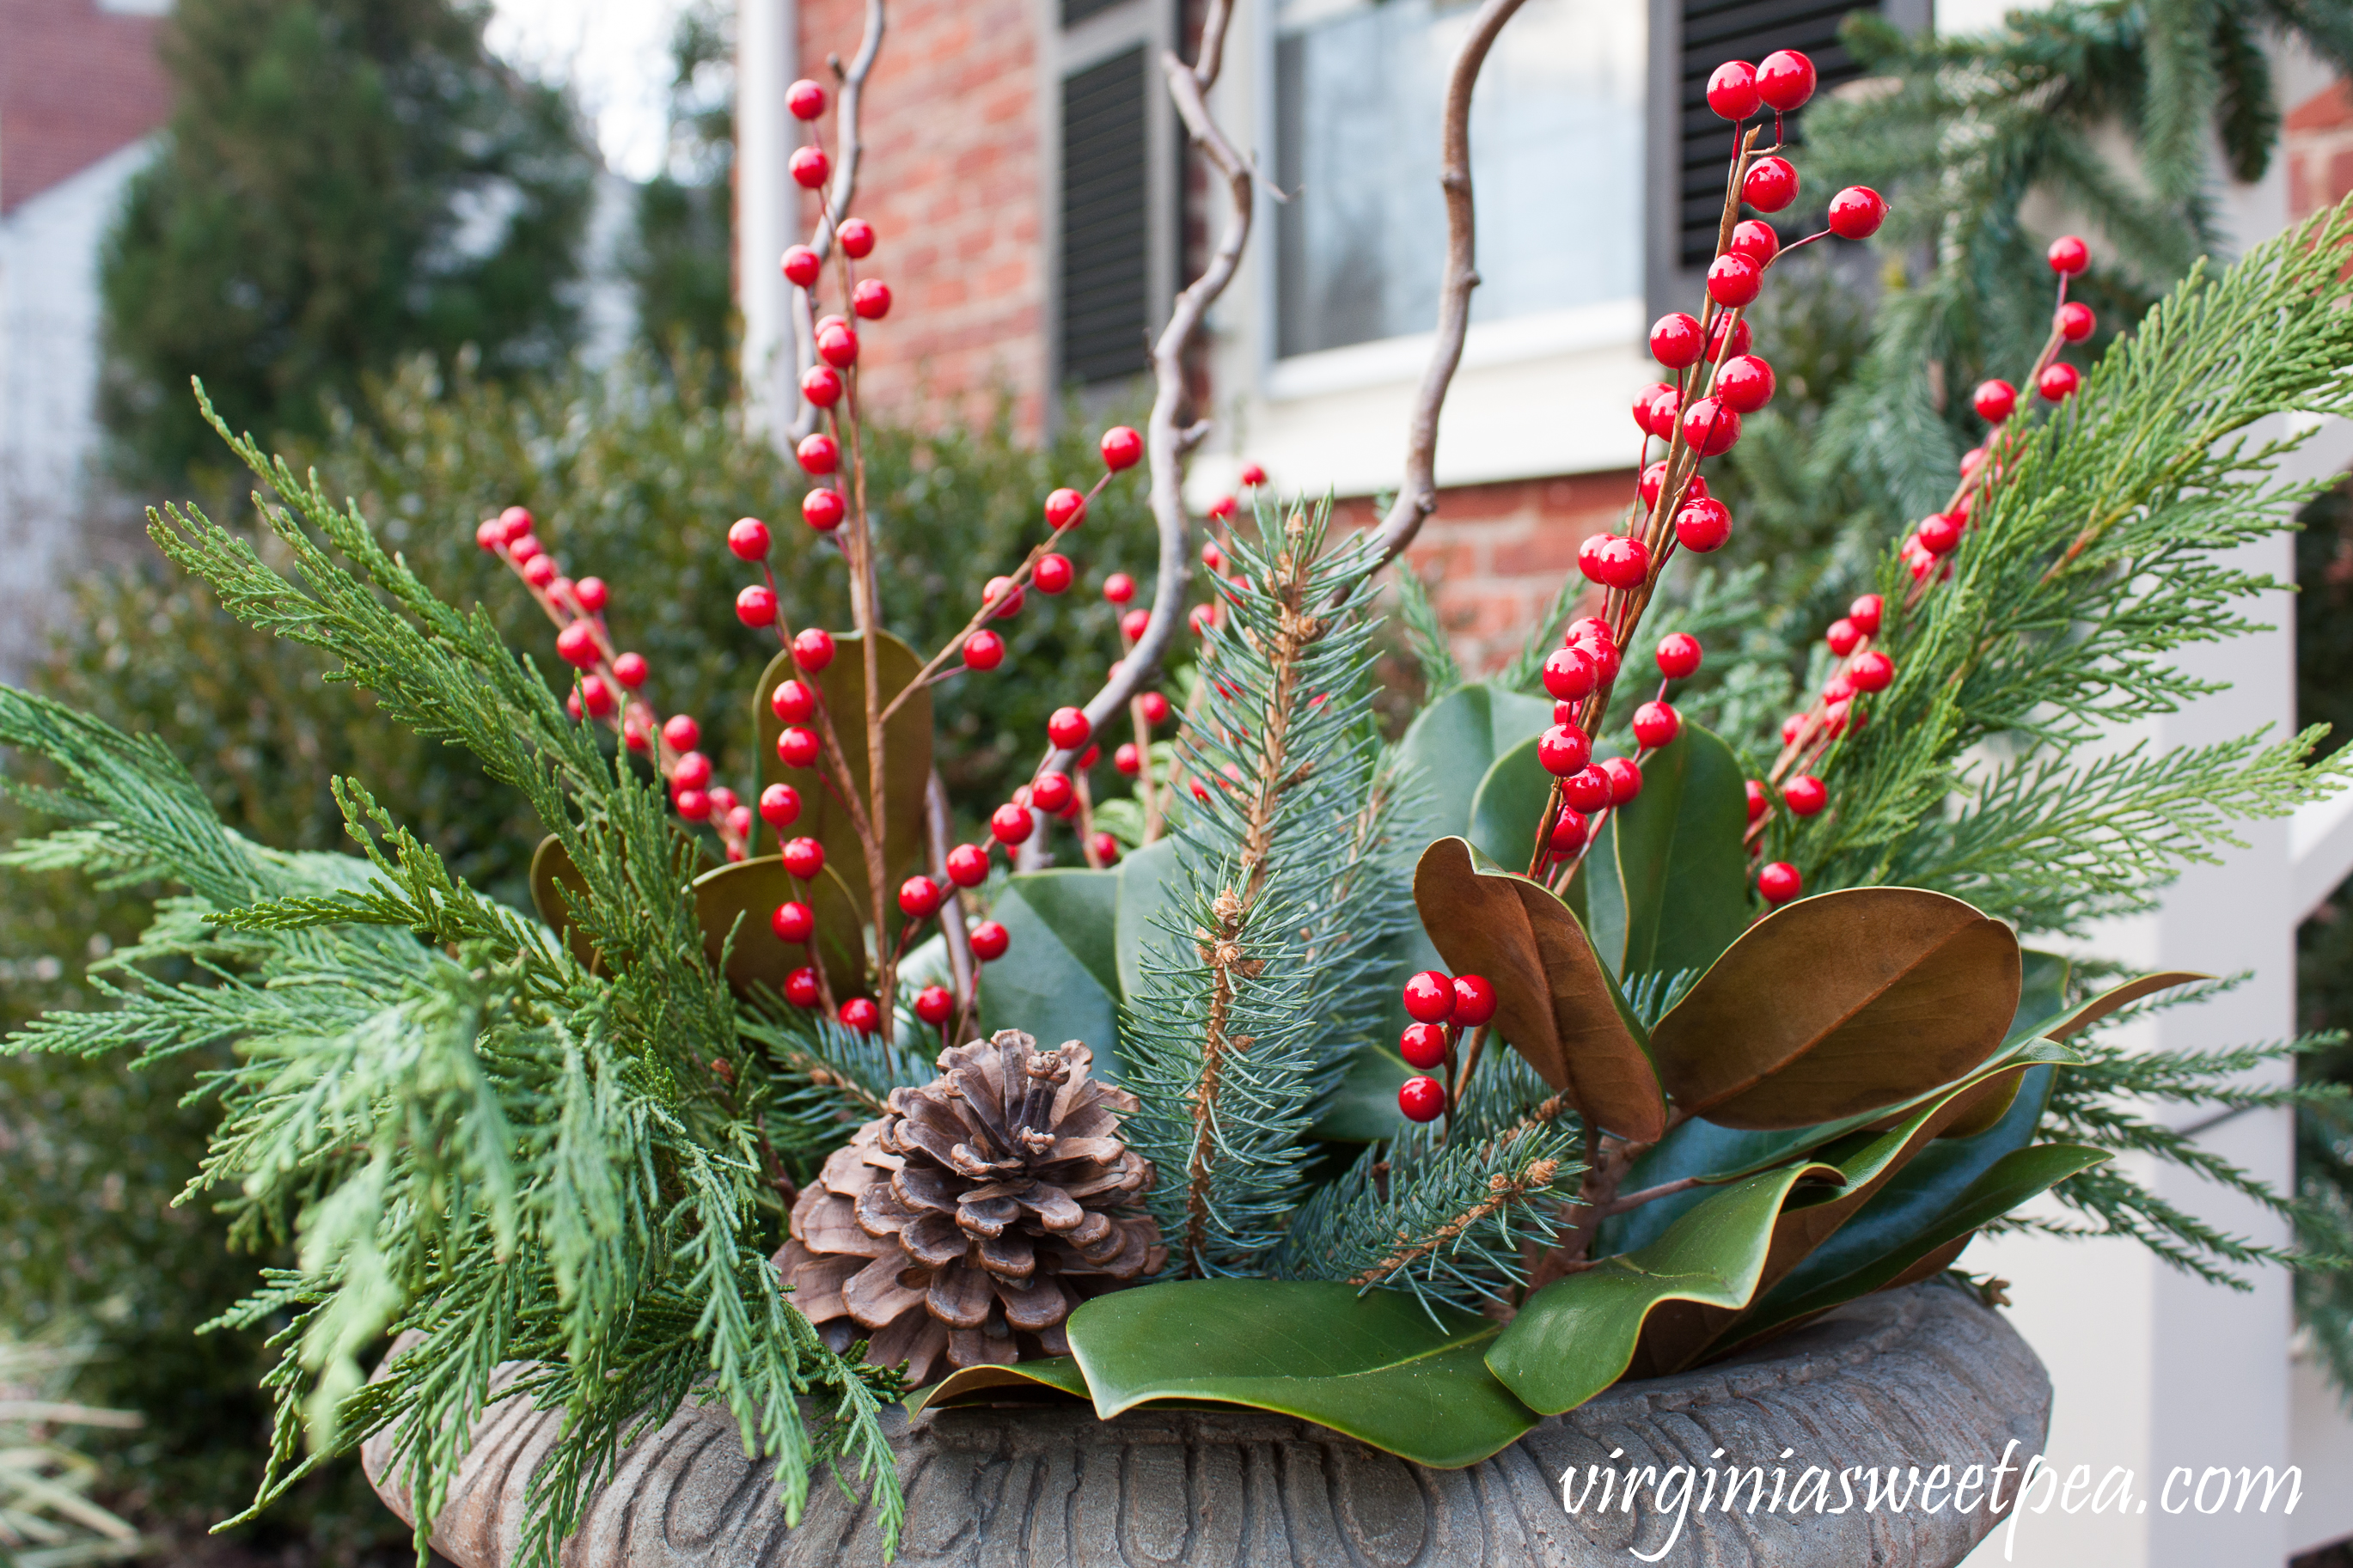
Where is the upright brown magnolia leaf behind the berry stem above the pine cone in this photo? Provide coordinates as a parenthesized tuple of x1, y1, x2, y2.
(750, 632, 932, 997)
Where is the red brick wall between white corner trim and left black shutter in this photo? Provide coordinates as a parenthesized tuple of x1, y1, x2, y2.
(800, 0, 1047, 440)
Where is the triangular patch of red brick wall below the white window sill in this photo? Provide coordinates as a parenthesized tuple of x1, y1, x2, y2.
(1339, 470, 1633, 673)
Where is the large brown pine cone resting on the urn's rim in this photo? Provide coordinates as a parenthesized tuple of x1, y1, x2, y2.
(777, 1029, 1167, 1385)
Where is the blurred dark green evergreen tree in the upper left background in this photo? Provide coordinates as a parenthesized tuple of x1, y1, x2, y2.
(101, 0, 593, 485)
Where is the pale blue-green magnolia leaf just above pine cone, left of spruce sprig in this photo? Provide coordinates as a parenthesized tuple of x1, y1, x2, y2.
(981, 869, 1120, 1077)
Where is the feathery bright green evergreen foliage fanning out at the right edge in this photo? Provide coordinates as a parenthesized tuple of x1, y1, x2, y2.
(1767, 196, 2353, 933)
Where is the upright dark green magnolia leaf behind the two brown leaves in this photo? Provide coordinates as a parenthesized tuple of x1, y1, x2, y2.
(1571, 724, 1748, 983)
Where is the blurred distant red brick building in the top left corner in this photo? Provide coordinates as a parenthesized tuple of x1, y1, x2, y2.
(0, 0, 172, 214)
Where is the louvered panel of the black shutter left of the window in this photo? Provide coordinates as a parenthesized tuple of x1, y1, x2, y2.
(1061, 48, 1151, 383)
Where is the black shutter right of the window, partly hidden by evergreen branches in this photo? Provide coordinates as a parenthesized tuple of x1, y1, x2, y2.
(1675, 0, 1880, 268)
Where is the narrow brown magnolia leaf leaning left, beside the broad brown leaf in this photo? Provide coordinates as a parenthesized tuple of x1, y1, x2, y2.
(1415, 839, 1666, 1143)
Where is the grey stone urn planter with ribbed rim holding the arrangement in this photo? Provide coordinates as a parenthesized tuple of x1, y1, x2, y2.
(363, 1281, 2052, 1568)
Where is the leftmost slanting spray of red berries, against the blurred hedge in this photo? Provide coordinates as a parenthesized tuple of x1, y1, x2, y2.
(473, 505, 750, 860)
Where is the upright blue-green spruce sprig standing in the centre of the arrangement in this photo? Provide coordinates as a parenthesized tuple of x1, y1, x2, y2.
(1120, 505, 1409, 1277)
